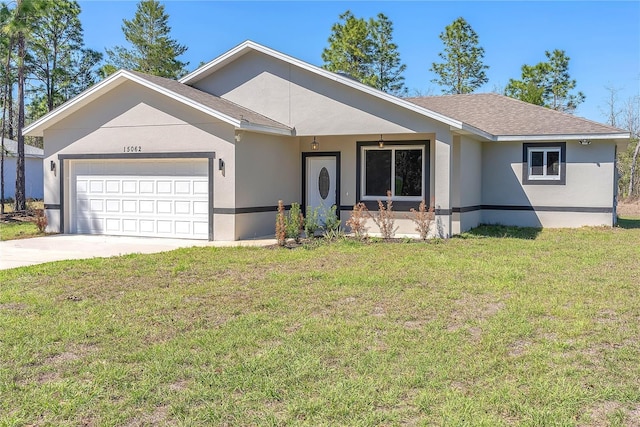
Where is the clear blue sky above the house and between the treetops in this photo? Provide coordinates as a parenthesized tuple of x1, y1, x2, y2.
(79, 0, 640, 121)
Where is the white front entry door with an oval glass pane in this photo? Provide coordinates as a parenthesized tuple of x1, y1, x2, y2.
(305, 155, 339, 222)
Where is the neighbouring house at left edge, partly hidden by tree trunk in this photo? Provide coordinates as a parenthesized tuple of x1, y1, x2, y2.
(4, 138, 44, 199)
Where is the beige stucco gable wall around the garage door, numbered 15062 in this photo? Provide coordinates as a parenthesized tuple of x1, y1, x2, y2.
(44, 83, 236, 240)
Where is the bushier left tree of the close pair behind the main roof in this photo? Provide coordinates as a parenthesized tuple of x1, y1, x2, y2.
(322, 10, 373, 84)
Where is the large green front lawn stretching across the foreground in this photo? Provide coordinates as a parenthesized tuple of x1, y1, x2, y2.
(0, 226, 640, 426)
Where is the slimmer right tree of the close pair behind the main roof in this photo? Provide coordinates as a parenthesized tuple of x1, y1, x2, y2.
(369, 13, 407, 95)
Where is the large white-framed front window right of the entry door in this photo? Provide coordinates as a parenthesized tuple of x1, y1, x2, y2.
(361, 145, 425, 200)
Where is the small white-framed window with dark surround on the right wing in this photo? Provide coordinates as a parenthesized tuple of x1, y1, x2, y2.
(522, 142, 566, 185)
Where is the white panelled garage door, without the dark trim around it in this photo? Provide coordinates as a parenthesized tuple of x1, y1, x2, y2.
(72, 162, 209, 239)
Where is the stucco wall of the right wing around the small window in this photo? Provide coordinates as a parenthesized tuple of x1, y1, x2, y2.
(482, 141, 615, 227)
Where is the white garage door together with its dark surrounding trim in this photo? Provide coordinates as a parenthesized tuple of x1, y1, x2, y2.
(58, 152, 215, 240)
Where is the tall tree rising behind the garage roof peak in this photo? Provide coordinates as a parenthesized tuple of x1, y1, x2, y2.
(103, 0, 188, 78)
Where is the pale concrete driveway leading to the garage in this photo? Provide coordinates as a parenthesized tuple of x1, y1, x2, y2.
(0, 234, 276, 270)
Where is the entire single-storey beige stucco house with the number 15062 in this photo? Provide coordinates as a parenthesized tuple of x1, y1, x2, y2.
(25, 41, 629, 240)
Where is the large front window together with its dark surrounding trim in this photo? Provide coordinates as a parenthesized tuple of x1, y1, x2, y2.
(356, 140, 430, 211)
